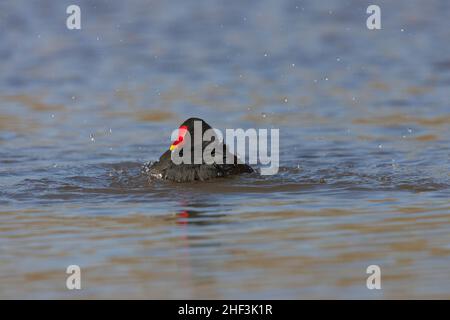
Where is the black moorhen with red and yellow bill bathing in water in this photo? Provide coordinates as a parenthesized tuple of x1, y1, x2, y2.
(145, 118, 253, 182)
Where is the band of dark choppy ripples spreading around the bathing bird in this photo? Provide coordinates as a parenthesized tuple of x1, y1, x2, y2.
(1, 162, 450, 203)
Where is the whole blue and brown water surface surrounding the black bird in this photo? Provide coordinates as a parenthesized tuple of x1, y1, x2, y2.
(0, 0, 450, 299)
